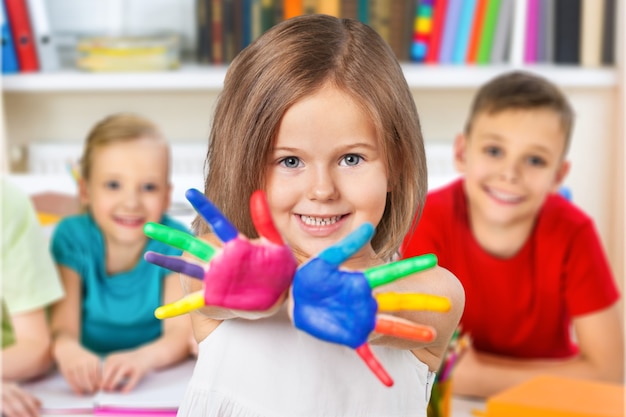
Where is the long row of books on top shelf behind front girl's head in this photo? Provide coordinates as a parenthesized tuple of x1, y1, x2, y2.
(196, 0, 616, 66)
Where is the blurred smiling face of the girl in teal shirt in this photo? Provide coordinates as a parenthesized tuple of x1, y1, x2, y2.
(81, 138, 171, 250)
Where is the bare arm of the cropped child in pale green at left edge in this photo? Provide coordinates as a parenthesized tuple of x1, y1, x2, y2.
(2, 308, 52, 381)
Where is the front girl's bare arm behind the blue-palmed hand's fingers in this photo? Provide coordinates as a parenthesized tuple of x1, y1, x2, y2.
(369, 266, 465, 371)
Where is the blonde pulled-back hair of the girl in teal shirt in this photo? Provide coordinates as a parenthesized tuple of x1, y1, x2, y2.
(80, 113, 166, 180)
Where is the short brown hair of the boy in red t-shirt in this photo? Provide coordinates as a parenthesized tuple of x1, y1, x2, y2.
(465, 71, 575, 153)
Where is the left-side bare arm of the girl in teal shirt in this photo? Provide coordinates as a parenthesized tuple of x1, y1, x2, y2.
(51, 265, 100, 394)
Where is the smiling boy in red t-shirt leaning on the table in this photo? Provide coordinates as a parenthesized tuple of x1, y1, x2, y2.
(402, 72, 624, 397)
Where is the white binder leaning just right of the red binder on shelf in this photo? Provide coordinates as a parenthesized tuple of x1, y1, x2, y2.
(26, 0, 61, 72)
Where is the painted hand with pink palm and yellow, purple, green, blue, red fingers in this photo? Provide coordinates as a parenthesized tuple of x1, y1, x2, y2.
(144, 189, 297, 318)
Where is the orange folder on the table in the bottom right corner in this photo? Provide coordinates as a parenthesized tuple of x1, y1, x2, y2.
(485, 375, 624, 417)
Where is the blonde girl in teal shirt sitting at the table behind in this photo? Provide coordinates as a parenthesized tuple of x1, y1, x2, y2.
(52, 113, 191, 394)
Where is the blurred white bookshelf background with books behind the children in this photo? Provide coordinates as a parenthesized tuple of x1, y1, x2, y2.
(0, 0, 626, 318)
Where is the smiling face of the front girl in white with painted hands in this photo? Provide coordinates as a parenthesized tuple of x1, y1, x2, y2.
(266, 86, 388, 267)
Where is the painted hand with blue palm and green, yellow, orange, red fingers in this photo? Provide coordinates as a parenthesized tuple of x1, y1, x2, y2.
(292, 223, 450, 386)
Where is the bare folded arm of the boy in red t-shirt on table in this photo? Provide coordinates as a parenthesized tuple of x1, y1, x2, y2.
(453, 305, 624, 397)
